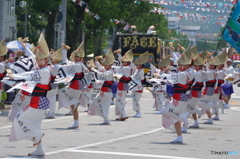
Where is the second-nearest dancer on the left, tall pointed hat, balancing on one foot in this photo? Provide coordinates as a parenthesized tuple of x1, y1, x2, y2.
(59, 42, 88, 129)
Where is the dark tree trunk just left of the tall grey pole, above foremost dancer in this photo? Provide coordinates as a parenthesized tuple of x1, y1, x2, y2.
(45, 10, 57, 49)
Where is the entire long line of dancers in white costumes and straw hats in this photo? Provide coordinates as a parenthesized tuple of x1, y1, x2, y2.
(0, 34, 238, 156)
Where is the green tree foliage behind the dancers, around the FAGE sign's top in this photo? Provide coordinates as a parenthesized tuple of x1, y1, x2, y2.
(16, 0, 168, 55)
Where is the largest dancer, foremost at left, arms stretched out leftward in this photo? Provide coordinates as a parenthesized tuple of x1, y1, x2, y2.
(9, 34, 51, 156)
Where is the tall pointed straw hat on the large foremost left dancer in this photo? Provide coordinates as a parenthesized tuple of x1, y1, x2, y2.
(34, 33, 49, 59)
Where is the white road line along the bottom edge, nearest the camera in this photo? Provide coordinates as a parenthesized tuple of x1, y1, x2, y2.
(67, 150, 199, 159)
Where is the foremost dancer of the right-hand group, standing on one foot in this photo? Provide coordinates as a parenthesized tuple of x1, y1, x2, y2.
(162, 48, 191, 143)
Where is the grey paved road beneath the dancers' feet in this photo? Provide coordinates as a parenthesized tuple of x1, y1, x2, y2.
(0, 87, 240, 159)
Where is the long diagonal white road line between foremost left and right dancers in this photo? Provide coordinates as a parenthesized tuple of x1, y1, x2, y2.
(46, 127, 165, 155)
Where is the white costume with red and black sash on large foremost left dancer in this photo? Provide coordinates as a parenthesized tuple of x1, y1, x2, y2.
(9, 67, 50, 143)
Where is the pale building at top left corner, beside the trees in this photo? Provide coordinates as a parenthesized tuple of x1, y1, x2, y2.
(4, 0, 17, 41)
